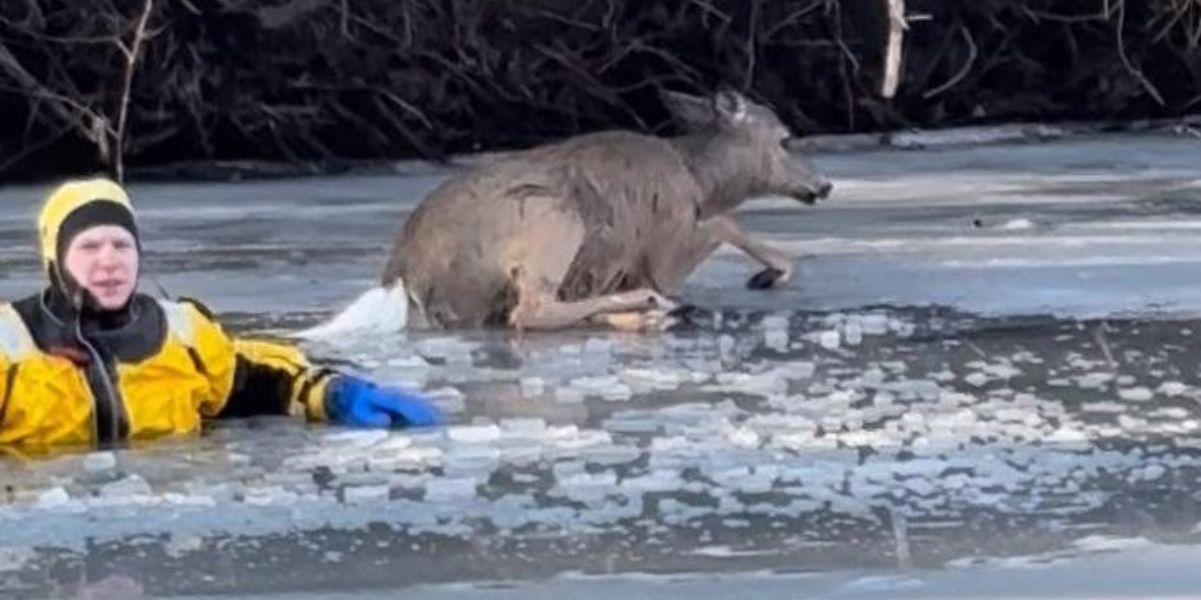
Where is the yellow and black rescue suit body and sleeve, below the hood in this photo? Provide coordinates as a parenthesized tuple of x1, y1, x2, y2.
(0, 295, 331, 445)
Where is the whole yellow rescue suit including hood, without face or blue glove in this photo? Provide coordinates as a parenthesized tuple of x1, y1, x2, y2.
(0, 179, 335, 446)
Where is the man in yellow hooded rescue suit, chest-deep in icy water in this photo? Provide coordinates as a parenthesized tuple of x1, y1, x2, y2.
(0, 179, 442, 446)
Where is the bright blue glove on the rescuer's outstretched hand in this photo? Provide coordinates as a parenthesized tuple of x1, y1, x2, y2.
(325, 374, 443, 427)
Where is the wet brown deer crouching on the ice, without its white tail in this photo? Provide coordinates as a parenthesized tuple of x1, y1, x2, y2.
(383, 91, 831, 329)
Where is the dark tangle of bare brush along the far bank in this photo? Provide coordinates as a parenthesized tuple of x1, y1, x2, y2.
(0, 0, 1201, 178)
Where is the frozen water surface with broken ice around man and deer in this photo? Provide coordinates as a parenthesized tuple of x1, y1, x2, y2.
(0, 134, 1201, 600)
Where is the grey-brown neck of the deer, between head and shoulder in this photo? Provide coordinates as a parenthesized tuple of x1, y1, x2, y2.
(675, 132, 754, 218)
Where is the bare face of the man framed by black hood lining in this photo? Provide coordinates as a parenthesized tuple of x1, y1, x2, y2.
(64, 224, 138, 311)
